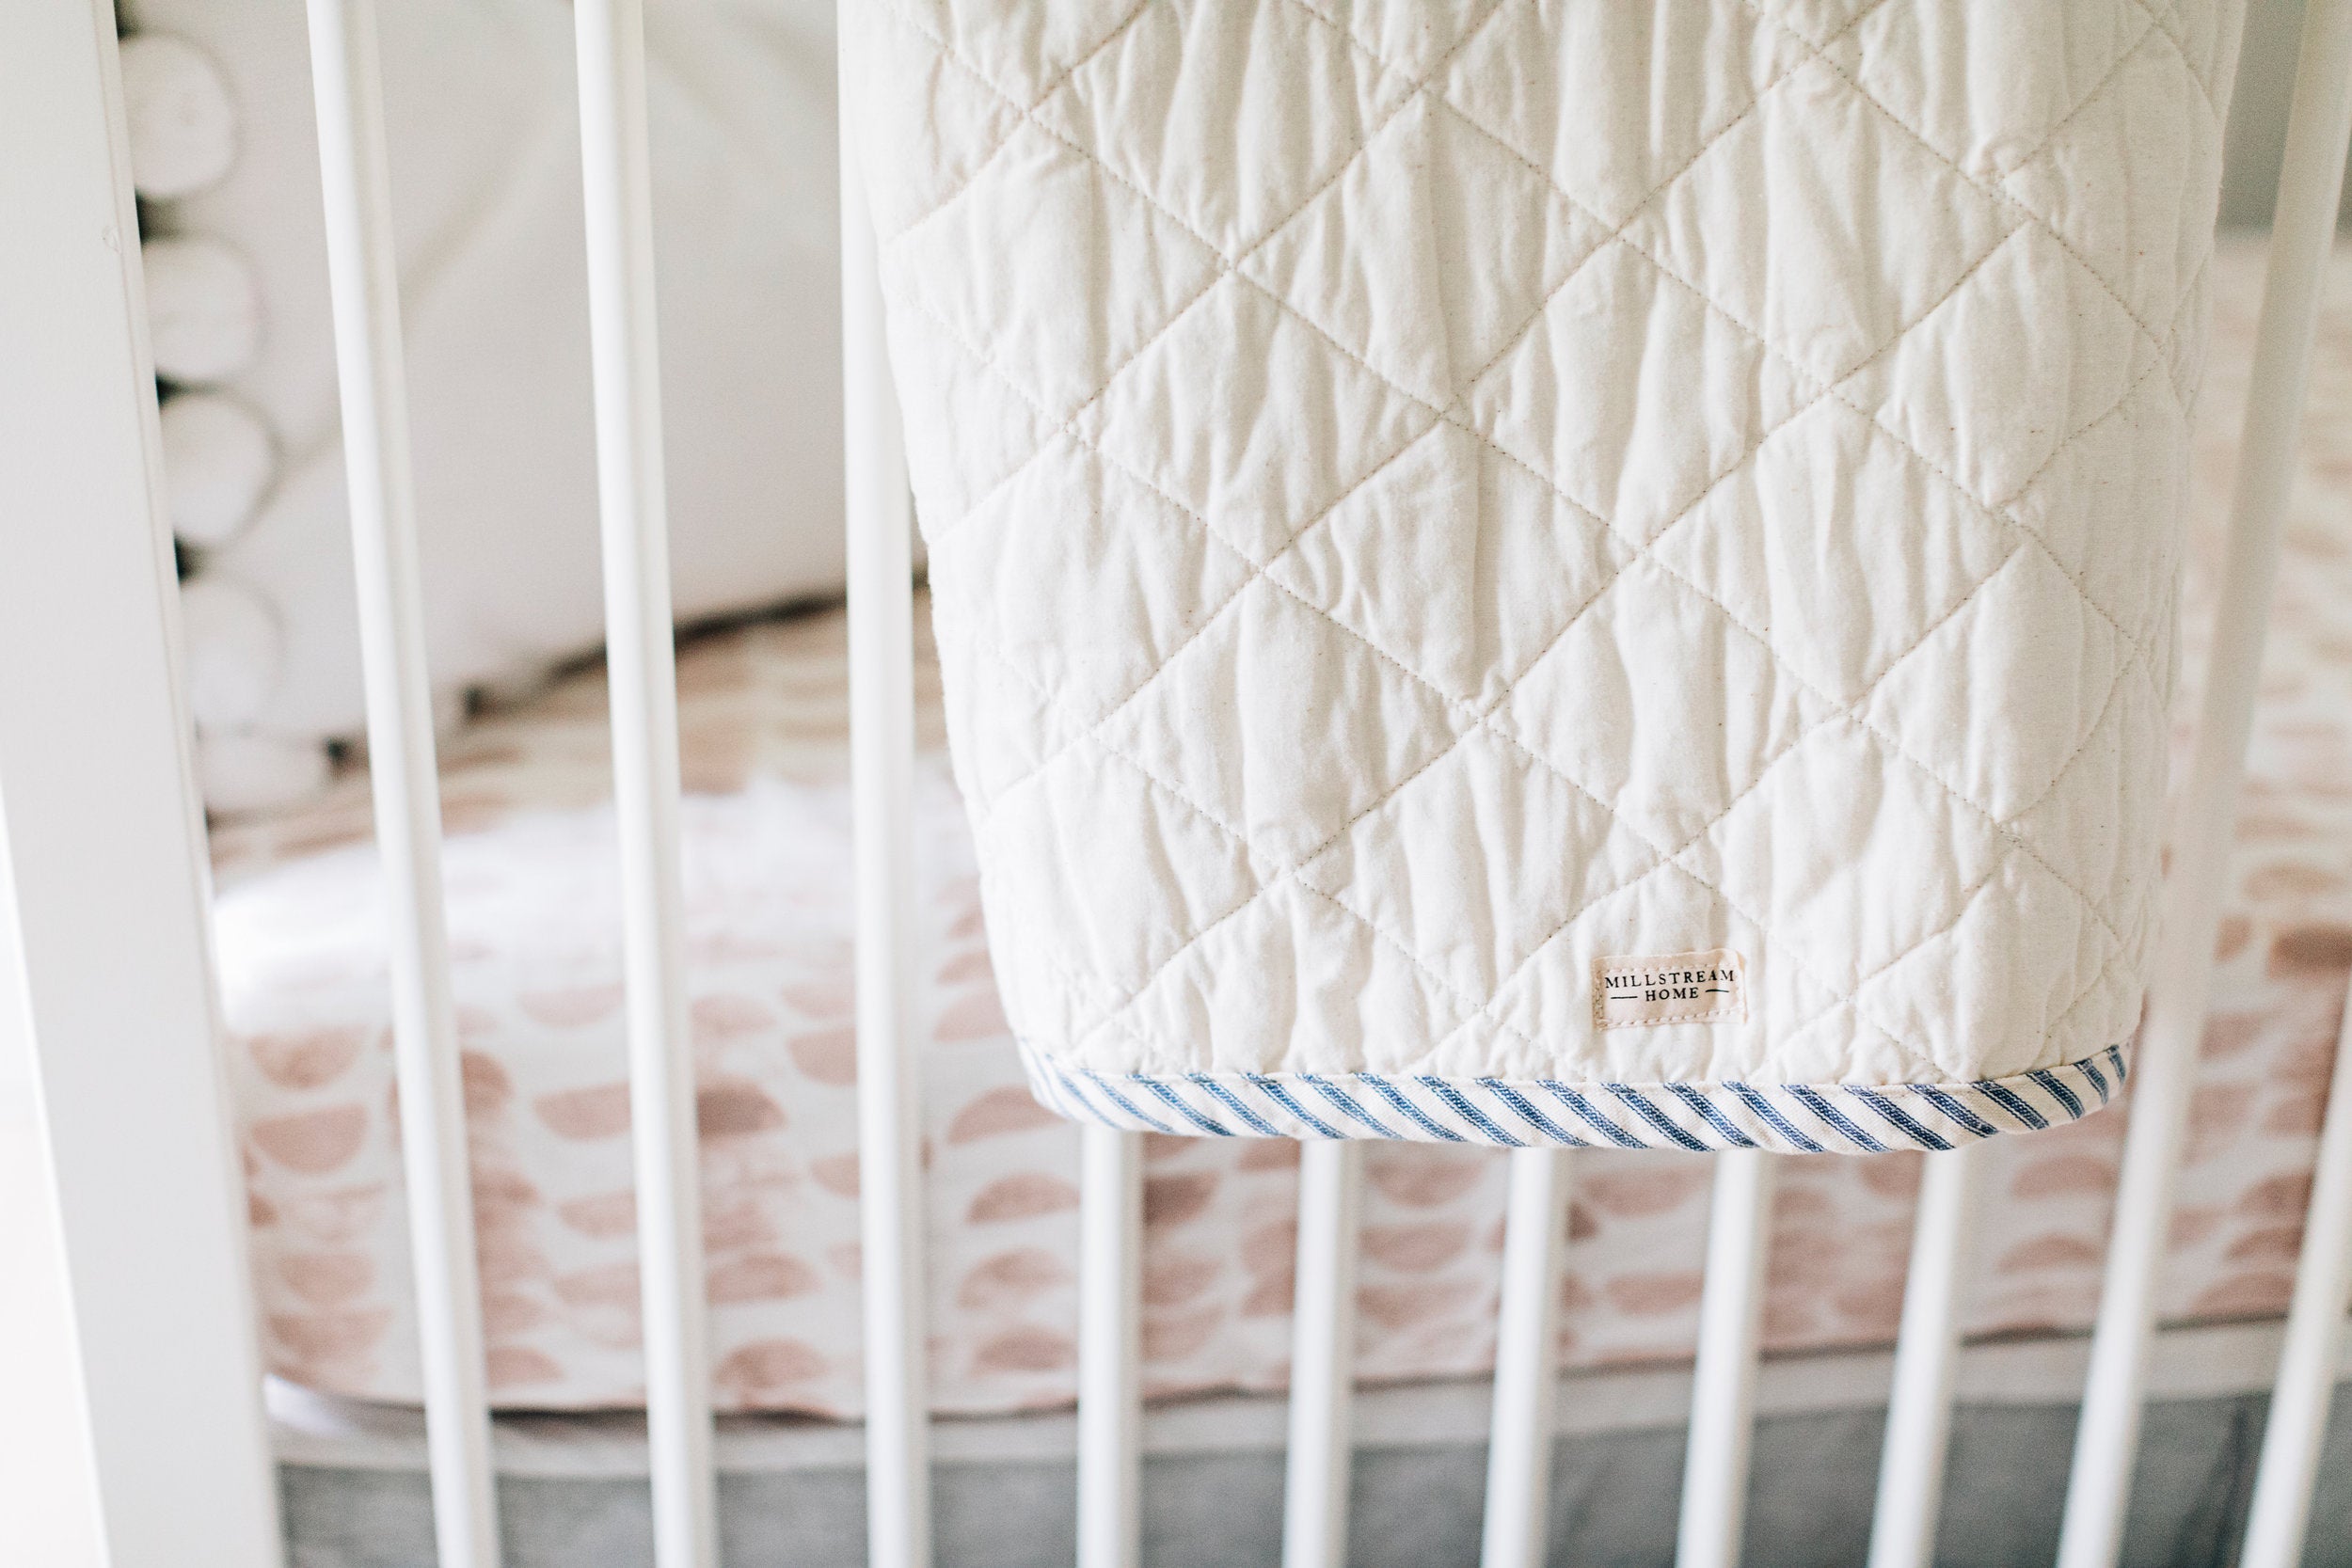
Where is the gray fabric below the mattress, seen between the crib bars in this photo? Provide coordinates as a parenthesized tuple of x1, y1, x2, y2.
(282, 1385, 2352, 1568)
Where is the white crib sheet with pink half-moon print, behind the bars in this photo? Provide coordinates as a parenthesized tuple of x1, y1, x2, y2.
(215, 245, 2352, 1418)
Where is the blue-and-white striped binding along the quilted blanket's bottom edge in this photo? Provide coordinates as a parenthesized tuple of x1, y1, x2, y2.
(1021, 1044, 2129, 1154)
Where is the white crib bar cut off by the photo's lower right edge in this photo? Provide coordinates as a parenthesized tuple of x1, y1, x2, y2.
(2239, 968, 2352, 1568)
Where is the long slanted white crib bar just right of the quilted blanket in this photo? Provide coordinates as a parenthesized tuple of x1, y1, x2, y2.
(2058, 0, 2352, 1568)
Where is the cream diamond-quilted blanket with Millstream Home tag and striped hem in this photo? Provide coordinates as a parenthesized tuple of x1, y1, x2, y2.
(847, 0, 2239, 1152)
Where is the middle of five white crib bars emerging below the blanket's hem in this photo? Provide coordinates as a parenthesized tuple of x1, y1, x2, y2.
(1480, 1149, 1574, 1568)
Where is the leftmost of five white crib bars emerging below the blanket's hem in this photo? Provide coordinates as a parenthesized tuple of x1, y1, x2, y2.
(1077, 1126, 1143, 1568)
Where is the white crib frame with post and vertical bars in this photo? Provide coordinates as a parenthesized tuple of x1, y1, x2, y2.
(13, 0, 2352, 1568)
